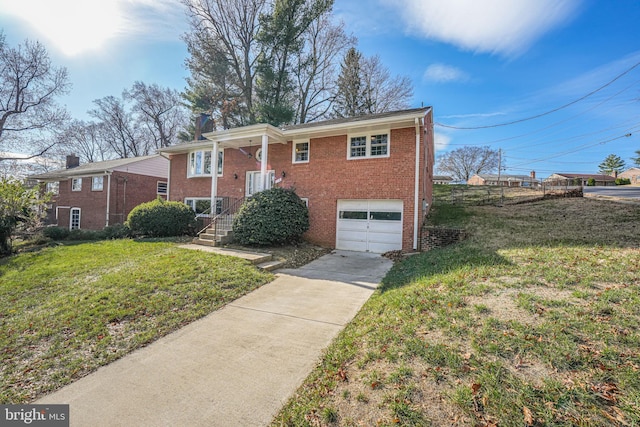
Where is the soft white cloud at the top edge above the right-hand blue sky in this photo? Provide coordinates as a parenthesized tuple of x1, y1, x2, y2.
(386, 0, 583, 56)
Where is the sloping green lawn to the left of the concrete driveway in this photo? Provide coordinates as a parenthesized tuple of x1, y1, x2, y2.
(0, 240, 273, 404)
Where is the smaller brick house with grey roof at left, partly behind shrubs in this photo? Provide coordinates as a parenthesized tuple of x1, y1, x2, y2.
(29, 155, 169, 230)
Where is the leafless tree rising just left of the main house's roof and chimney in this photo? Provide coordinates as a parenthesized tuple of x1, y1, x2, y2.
(124, 82, 188, 149)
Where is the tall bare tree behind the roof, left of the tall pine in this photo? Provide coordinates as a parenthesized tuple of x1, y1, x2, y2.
(182, 0, 267, 124)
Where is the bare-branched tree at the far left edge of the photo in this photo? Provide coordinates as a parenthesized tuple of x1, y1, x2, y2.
(0, 33, 70, 156)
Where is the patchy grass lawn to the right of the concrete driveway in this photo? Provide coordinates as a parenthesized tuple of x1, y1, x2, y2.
(273, 199, 640, 426)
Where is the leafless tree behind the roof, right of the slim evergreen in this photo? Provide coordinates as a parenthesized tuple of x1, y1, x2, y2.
(362, 55, 413, 114)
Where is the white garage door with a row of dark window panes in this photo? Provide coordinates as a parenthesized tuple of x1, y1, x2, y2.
(336, 200, 402, 253)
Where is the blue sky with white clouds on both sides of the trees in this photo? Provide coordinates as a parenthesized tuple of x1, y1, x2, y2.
(0, 0, 640, 178)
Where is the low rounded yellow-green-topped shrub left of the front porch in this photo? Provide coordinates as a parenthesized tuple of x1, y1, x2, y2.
(126, 199, 196, 237)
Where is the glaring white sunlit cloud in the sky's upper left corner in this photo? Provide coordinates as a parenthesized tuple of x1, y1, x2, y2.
(0, 0, 184, 56)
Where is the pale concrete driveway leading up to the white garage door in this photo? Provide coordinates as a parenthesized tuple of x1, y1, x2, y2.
(34, 251, 392, 427)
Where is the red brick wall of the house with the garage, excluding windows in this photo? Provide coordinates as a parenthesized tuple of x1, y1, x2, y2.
(169, 123, 433, 251)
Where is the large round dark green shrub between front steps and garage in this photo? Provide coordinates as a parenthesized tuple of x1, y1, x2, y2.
(233, 188, 309, 245)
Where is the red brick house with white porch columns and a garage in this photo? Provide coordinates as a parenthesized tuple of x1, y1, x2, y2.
(160, 108, 434, 253)
